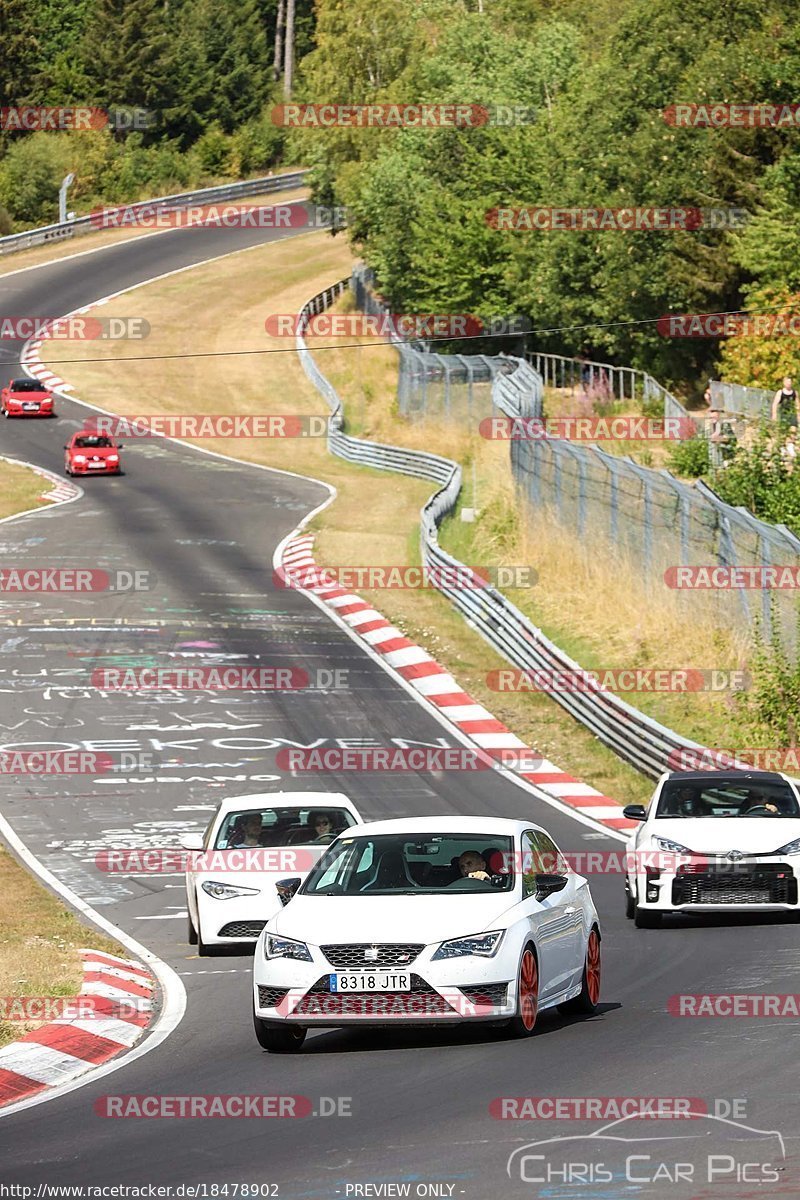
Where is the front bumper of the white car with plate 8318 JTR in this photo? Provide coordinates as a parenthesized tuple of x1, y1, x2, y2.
(253, 941, 516, 1026)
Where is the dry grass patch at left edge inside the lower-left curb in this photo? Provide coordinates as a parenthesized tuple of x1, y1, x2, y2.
(0, 847, 119, 1045)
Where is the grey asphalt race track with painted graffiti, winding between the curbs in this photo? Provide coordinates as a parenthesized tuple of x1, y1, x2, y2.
(0, 229, 800, 1200)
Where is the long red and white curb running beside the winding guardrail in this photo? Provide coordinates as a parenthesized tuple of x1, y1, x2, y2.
(281, 534, 637, 830)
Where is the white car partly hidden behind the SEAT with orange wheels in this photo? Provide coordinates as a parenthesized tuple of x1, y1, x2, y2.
(181, 792, 361, 955)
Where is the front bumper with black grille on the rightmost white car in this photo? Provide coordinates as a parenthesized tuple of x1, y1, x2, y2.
(636, 854, 800, 912)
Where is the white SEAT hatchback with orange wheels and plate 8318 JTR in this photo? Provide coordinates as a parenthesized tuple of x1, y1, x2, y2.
(253, 817, 600, 1051)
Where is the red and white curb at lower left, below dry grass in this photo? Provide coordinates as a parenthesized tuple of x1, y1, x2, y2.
(0, 950, 155, 1106)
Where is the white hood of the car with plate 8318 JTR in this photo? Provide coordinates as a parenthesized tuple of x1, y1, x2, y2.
(269, 892, 513, 946)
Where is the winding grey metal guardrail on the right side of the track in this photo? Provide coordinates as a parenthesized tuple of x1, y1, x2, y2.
(296, 280, 704, 779)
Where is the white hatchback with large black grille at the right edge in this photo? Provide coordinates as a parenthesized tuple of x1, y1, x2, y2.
(624, 770, 800, 929)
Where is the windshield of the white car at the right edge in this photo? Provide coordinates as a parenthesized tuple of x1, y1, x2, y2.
(656, 779, 800, 820)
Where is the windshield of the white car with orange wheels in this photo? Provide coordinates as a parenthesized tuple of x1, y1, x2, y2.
(301, 833, 513, 896)
